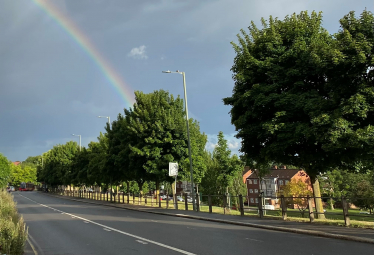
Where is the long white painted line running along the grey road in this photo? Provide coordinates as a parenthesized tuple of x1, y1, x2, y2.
(20, 195, 196, 255)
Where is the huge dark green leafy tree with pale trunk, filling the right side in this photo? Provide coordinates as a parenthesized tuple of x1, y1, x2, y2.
(223, 11, 374, 217)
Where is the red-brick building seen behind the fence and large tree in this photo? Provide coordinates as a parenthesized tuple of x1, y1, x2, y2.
(243, 166, 312, 207)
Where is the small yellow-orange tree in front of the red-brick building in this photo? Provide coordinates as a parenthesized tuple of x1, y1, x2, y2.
(280, 180, 313, 218)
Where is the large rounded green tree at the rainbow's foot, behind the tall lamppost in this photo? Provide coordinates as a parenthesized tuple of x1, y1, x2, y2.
(108, 90, 206, 195)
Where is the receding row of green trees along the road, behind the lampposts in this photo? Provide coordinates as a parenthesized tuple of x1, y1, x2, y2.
(38, 90, 246, 197)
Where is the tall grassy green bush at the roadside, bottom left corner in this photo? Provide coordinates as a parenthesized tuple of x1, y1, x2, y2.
(0, 191, 27, 255)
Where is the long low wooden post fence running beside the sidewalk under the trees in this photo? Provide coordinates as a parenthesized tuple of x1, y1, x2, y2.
(44, 188, 374, 227)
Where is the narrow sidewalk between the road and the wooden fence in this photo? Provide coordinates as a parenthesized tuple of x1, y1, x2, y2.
(48, 194, 374, 244)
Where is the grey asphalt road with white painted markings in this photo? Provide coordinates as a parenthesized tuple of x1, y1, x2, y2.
(13, 192, 374, 255)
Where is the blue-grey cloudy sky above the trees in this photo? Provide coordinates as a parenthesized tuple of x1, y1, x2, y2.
(0, 0, 374, 161)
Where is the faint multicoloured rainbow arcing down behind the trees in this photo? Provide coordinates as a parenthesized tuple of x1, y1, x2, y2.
(33, 0, 135, 107)
